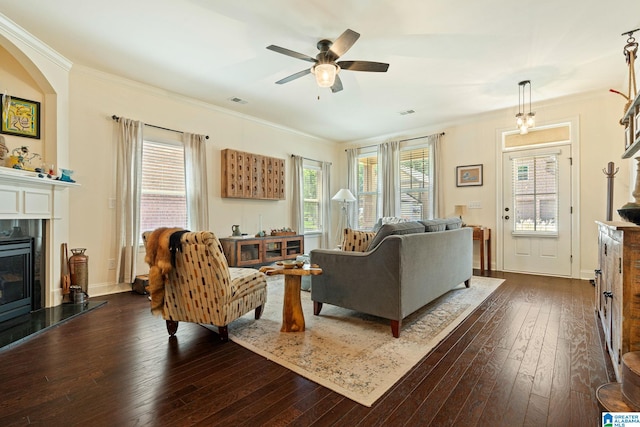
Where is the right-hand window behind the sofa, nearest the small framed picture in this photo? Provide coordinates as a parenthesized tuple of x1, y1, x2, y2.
(400, 147, 433, 221)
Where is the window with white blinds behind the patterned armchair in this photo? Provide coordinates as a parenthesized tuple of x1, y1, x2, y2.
(140, 141, 188, 231)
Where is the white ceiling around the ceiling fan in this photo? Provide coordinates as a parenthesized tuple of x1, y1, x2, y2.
(0, 0, 640, 141)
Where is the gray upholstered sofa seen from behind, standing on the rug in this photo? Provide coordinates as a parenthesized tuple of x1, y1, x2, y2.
(310, 221, 473, 338)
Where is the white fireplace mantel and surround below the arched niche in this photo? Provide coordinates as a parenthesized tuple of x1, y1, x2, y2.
(0, 167, 78, 307)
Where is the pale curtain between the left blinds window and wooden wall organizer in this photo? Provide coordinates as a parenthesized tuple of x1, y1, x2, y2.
(182, 132, 209, 231)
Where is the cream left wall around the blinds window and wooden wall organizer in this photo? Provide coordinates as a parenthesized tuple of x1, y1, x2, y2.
(68, 66, 344, 296)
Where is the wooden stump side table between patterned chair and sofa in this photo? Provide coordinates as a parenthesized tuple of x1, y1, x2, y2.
(260, 264, 322, 332)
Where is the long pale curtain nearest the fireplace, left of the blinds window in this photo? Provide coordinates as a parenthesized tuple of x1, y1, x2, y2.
(116, 117, 144, 283)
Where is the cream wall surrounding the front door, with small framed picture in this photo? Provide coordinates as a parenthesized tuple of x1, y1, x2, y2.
(348, 89, 636, 279)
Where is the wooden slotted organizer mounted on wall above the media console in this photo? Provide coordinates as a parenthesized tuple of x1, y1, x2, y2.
(221, 148, 285, 200)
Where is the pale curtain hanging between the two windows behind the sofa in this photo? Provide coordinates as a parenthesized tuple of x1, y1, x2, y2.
(378, 141, 400, 217)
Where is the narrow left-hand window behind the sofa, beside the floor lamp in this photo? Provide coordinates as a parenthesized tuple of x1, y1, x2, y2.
(358, 153, 378, 230)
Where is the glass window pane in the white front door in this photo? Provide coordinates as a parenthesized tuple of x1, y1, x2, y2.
(513, 154, 558, 233)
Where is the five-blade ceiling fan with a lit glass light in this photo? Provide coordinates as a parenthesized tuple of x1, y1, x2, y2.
(267, 29, 389, 93)
